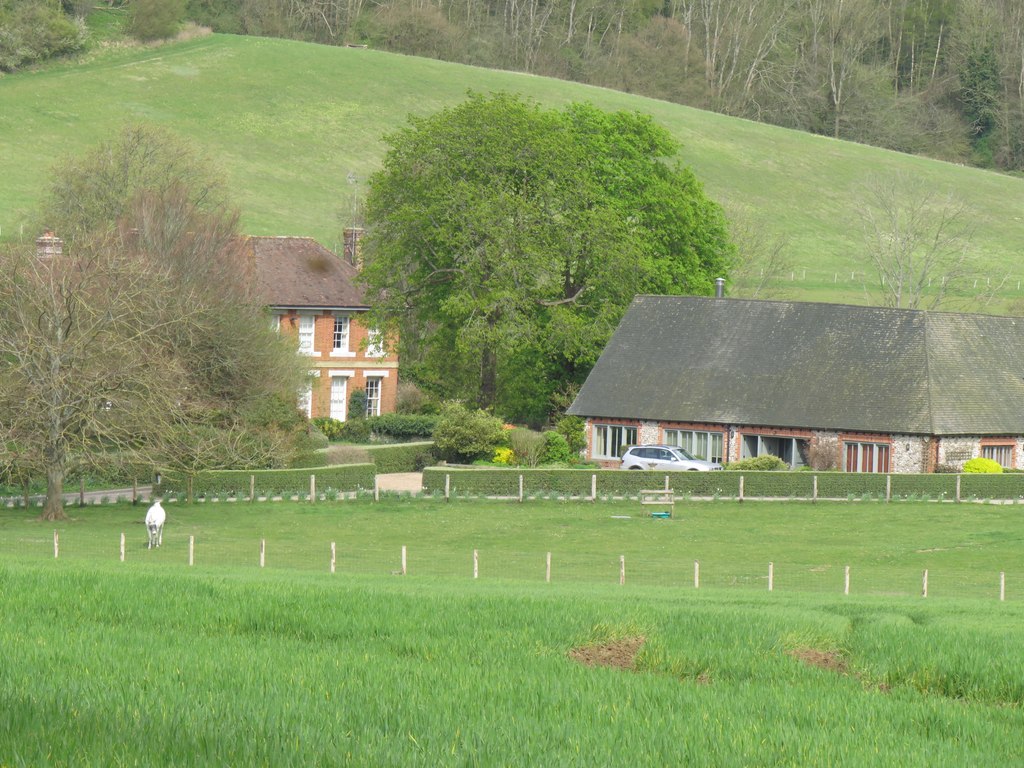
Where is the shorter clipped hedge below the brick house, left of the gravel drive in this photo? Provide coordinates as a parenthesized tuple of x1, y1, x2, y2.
(160, 464, 375, 498)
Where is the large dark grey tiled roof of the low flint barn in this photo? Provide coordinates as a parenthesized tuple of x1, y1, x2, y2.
(569, 296, 1024, 435)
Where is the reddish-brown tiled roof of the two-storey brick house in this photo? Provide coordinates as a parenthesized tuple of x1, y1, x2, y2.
(245, 237, 370, 309)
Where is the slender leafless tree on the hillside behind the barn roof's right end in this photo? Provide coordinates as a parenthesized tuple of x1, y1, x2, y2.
(857, 174, 974, 309)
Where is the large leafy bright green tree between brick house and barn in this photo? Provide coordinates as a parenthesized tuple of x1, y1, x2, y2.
(362, 93, 732, 420)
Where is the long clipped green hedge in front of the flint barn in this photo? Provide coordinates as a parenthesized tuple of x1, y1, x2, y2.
(423, 467, 1024, 500)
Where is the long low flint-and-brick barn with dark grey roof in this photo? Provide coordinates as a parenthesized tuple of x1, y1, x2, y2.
(569, 296, 1024, 472)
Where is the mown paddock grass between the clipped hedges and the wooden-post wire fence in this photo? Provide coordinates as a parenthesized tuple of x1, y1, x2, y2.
(0, 499, 1024, 601)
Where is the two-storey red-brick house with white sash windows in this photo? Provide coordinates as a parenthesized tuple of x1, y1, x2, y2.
(245, 229, 398, 421)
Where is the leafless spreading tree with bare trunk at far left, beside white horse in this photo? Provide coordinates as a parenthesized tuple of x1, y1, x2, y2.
(0, 242, 181, 519)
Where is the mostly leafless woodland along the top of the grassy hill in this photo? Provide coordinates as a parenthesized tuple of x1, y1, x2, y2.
(180, 0, 1024, 170)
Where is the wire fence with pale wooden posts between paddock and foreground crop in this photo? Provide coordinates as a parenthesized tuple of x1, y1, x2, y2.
(8, 524, 1024, 602)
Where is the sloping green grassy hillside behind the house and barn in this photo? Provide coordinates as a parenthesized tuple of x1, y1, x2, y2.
(0, 35, 1024, 308)
